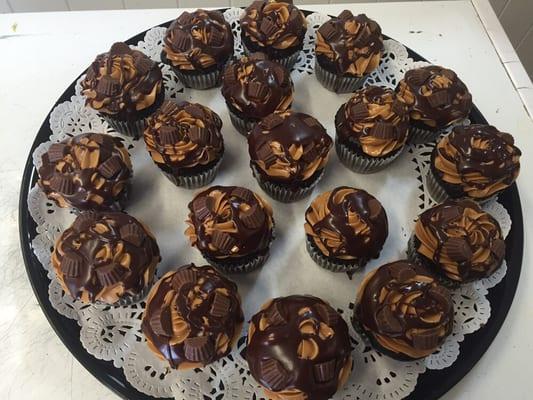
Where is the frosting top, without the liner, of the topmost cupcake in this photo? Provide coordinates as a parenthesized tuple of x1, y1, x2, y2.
(240, 0, 307, 52)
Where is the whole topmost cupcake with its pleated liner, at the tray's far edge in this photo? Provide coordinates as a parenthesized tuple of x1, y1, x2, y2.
(240, 0, 307, 70)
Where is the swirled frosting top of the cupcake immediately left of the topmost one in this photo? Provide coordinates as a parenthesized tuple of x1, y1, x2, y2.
(163, 9, 233, 71)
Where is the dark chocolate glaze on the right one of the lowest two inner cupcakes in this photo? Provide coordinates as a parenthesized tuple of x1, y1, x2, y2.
(305, 186, 389, 263)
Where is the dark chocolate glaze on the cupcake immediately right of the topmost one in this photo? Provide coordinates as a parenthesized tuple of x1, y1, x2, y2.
(317, 10, 383, 76)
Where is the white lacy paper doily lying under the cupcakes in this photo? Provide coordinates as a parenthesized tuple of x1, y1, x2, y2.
(28, 8, 511, 400)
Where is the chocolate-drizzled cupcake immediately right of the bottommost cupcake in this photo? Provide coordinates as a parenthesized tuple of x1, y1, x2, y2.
(353, 260, 454, 361)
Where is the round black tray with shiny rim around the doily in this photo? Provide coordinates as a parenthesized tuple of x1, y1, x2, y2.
(19, 10, 524, 400)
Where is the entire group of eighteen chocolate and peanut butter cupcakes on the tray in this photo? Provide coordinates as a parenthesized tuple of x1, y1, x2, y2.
(38, 0, 521, 400)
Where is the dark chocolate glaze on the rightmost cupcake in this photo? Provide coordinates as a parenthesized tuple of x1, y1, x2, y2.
(432, 124, 522, 197)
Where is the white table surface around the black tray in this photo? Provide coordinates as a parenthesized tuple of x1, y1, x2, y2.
(0, 1, 533, 400)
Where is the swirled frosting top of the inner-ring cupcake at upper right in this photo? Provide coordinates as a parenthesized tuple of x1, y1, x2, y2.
(335, 86, 409, 157)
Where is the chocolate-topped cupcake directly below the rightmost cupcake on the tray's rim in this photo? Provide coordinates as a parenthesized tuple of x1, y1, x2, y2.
(408, 199, 505, 286)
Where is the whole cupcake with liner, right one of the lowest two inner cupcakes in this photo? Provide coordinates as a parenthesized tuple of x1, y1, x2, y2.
(304, 186, 389, 272)
